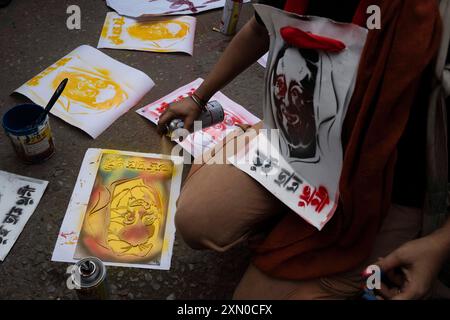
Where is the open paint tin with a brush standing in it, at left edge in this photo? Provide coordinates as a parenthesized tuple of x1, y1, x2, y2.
(3, 104, 55, 163)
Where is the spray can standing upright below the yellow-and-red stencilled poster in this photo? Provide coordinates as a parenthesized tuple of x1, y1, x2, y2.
(71, 257, 109, 300)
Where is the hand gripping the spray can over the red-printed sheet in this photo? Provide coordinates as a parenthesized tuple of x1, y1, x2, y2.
(158, 97, 201, 134)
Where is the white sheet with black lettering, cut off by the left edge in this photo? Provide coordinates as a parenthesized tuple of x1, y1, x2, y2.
(0, 170, 48, 261)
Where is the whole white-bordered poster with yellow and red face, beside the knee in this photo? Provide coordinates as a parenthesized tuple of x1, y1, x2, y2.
(52, 149, 183, 269)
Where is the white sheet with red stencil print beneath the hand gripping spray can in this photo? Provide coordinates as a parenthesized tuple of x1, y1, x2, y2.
(136, 78, 261, 157)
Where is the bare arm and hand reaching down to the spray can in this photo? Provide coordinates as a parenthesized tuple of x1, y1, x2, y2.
(158, 17, 269, 133)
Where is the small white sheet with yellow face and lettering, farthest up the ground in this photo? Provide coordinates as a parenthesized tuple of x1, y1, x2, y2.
(97, 12, 196, 55)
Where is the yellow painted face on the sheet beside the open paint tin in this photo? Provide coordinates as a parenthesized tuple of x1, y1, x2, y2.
(52, 69, 127, 110)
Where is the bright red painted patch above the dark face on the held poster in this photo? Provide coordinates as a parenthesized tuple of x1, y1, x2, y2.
(280, 27, 345, 52)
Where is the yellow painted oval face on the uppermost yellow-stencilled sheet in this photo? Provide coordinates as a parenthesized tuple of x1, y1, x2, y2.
(127, 20, 189, 41)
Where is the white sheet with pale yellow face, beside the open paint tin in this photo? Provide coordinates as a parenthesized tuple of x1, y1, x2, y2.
(15, 45, 154, 138)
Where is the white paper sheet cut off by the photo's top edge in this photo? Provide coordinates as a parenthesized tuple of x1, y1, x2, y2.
(106, 0, 250, 18)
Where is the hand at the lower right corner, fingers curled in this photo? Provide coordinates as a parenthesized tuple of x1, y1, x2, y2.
(376, 235, 448, 300)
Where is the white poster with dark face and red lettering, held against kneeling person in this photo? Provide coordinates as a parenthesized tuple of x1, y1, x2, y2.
(229, 5, 367, 229)
